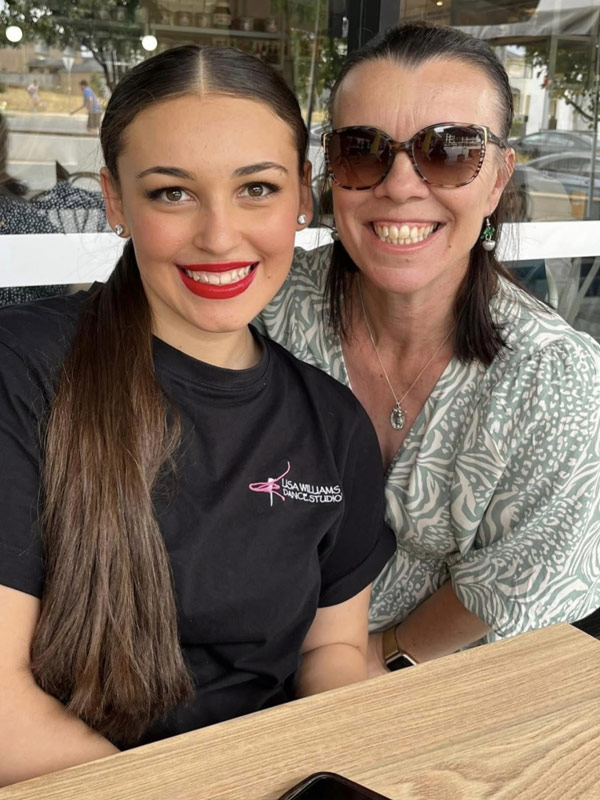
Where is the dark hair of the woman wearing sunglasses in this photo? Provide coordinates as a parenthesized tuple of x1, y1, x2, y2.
(327, 22, 517, 366)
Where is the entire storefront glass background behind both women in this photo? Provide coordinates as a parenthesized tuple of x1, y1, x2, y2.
(0, 0, 600, 338)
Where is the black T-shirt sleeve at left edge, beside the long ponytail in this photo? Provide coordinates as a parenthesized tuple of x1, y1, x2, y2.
(0, 342, 43, 597)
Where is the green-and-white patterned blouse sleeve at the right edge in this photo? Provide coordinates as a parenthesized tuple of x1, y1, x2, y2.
(450, 339, 600, 639)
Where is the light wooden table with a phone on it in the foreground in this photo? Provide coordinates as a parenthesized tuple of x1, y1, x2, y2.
(0, 625, 600, 800)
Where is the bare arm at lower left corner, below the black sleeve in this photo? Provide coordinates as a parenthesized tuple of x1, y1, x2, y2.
(0, 586, 118, 786)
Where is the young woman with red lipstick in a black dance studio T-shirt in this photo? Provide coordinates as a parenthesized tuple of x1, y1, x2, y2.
(0, 46, 393, 783)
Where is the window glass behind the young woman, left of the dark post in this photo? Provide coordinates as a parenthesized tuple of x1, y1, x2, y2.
(0, 0, 348, 302)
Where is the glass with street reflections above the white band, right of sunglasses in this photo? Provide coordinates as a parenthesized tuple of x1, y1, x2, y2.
(401, 0, 600, 222)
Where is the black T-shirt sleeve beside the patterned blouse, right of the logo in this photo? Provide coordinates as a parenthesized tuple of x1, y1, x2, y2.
(319, 408, 396, 607)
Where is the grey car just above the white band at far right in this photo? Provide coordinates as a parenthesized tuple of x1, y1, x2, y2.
(512, 151, 600, 221)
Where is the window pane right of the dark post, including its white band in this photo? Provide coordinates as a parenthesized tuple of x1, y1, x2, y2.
(400, 0, 600, 340)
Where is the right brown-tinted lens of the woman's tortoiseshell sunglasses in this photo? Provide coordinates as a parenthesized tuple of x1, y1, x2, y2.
(413, 125, 484, 186)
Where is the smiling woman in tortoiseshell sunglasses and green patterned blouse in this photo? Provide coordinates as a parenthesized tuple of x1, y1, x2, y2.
(262, 24, 600, 673)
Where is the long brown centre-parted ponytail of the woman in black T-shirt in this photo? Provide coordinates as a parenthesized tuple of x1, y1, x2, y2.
(32, 45, 307, 745)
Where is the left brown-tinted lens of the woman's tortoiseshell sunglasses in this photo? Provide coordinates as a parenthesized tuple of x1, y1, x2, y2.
(327, 128, 391, 189)
